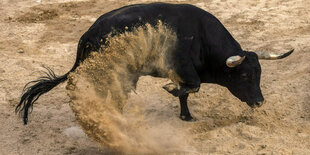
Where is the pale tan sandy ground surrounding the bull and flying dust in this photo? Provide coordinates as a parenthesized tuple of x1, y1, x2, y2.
(0, 0, 310, 155)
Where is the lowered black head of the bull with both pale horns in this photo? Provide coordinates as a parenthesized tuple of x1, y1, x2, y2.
(226, 50, 294, 108)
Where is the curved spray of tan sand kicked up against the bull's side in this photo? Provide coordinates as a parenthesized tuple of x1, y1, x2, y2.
(67, 21, 195, 154)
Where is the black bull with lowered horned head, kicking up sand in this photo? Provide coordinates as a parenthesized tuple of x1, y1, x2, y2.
(16, 3, 293, 124)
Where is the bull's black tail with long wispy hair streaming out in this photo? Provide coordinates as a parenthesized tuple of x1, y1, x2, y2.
(15, 66, 69, 124)
